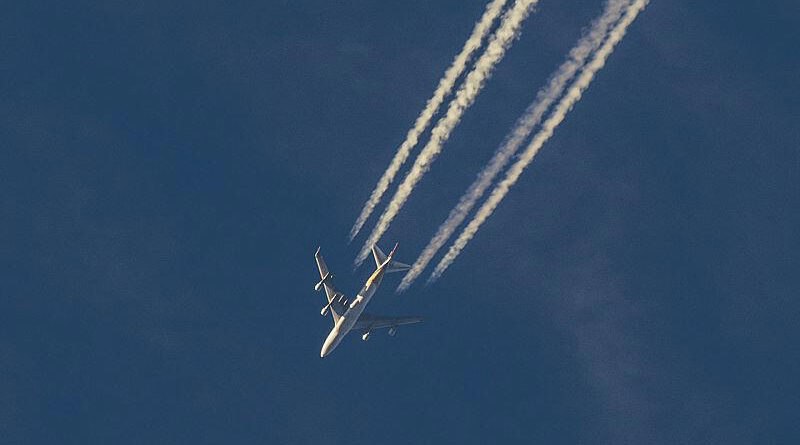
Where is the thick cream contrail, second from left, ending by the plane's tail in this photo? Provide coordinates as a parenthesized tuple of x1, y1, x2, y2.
(355, 0, 539, 265)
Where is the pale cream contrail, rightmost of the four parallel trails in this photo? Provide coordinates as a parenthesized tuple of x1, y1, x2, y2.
(428, 0, 649, 283)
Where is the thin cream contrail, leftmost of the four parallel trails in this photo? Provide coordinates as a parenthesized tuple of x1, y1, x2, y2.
(350, 0, 507, 241)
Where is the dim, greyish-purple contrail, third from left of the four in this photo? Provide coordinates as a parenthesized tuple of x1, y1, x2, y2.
(397, 0, 630, 292)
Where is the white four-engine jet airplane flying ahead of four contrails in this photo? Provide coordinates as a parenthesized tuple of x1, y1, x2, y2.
(314, 244, 422, 357)
